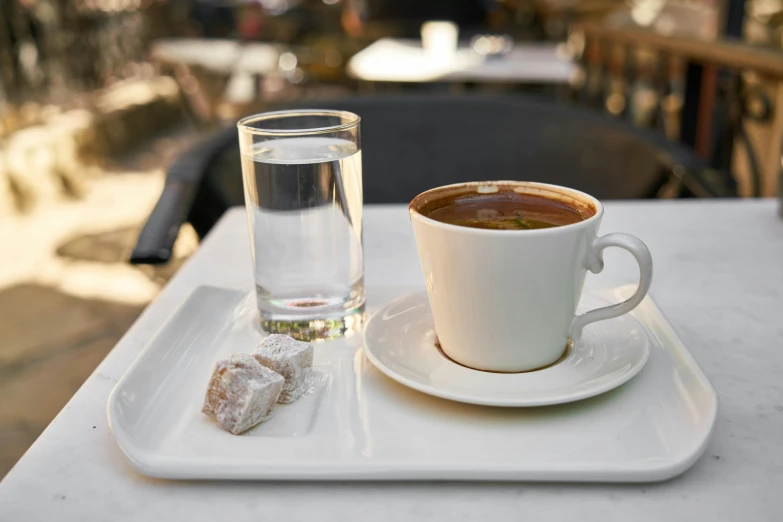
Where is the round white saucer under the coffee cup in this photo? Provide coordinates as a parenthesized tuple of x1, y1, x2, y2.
(364, 293, 650, 407)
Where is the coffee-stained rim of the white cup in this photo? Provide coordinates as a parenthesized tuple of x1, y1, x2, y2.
(408, 180, 604, 236)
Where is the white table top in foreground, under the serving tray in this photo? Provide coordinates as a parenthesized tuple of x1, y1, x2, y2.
(0, 200, 783, 522)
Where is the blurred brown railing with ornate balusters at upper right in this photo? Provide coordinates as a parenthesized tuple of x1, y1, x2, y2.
(573, 19, 783, 196)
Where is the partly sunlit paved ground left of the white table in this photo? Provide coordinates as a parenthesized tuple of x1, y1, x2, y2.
(0, 130, 196, 478)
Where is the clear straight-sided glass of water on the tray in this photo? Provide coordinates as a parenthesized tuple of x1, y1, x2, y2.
(237, 110, 364, 340)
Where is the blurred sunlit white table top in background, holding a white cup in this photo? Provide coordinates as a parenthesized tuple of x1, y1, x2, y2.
(347, 38, 577, 83)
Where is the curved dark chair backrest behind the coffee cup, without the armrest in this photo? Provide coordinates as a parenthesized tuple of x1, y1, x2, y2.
(312, 97, 702, 203)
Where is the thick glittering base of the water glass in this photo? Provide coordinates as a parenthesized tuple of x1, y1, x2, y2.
(261, 305, 364, 342)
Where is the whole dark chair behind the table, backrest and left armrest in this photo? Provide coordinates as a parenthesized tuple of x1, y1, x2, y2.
(131, 96, 731, 263)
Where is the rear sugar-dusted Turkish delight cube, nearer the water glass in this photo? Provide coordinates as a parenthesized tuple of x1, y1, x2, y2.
(253, 334, 313, 403)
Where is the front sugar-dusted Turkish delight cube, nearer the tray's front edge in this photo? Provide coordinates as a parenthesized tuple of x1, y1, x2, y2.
(201, 353, 285, 435)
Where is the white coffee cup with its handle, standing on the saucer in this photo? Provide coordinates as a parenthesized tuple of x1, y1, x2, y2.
(410, 181, 652, 372)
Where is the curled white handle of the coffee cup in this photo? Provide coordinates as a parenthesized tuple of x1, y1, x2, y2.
(569, 234, 652, 342)
